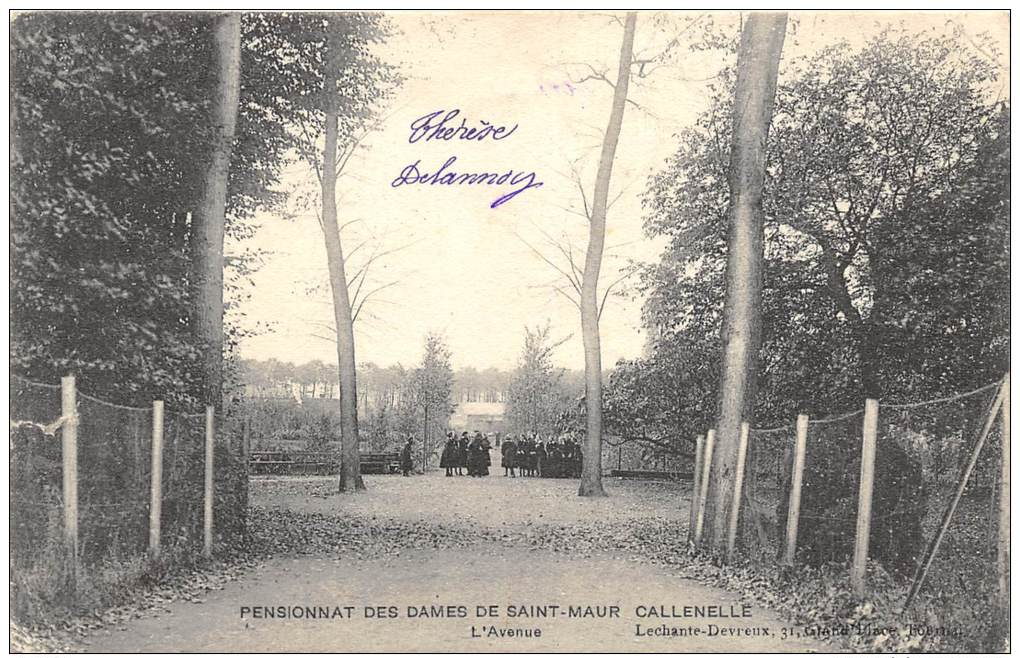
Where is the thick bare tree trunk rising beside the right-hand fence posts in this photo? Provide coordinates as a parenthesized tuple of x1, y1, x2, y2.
(705, 13, 786, 553)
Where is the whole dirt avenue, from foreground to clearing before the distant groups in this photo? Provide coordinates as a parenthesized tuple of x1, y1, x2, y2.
(77, 468, 832, 652)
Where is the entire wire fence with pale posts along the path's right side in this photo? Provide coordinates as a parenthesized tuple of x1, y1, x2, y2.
(692, 376, 1009, 640)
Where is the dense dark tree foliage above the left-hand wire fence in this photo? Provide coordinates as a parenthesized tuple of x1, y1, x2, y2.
(11, 12, 340, 404)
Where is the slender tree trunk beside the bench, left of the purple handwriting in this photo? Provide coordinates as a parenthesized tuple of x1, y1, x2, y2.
(322, 30, 365, 492)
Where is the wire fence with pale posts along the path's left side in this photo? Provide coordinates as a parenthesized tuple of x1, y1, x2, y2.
(9, 375, 247, 616)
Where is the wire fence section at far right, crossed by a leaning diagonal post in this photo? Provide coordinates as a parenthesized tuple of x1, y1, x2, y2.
(870, 387, 1008, 616)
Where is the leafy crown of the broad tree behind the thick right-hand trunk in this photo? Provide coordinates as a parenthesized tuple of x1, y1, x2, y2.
(638, 26, 1009, 438)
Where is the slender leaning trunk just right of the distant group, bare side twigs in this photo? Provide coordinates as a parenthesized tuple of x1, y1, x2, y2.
(577, 11, 638, 496)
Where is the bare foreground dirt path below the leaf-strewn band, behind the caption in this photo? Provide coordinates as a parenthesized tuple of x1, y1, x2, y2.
(86, 544, 830, 653)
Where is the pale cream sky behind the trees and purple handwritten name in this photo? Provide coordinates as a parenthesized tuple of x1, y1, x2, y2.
(227, 11, 1009, 369)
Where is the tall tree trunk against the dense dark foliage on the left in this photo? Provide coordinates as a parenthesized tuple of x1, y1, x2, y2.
(192, 13, 241, 410)
